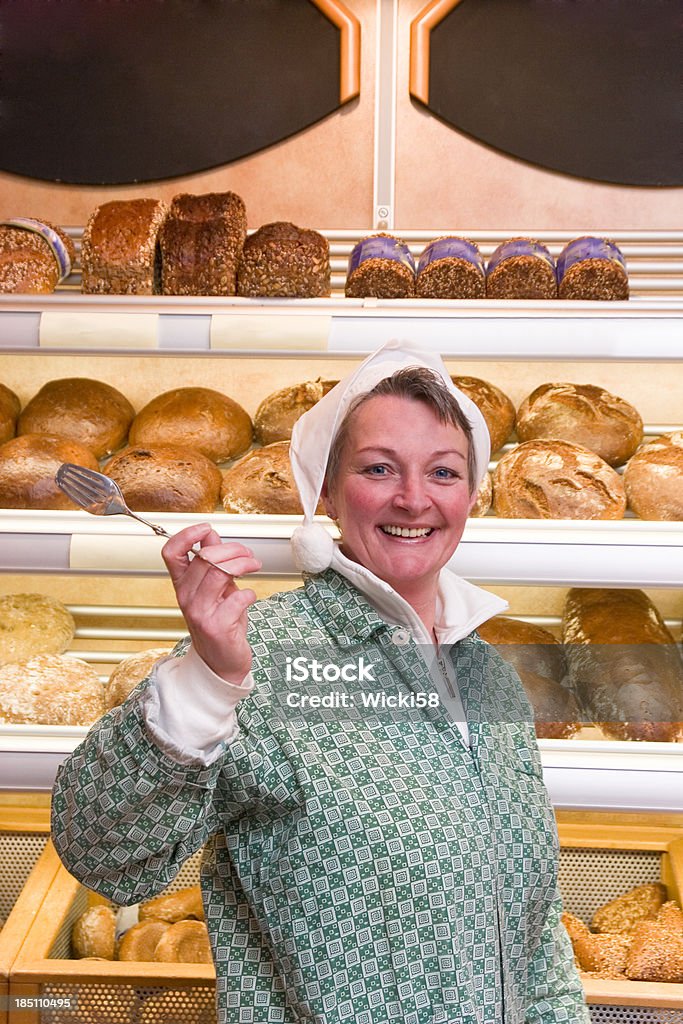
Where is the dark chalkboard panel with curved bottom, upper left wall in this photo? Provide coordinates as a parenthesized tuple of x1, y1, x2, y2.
(0, 0, 340, 184)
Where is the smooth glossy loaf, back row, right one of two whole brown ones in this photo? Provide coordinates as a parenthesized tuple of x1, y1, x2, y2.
(130, 387, 253, 462)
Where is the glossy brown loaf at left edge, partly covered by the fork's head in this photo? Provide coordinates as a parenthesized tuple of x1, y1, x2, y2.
(0, 434, 99, 509)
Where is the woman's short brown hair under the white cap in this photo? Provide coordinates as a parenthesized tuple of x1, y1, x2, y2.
(325, 367, 476, 494)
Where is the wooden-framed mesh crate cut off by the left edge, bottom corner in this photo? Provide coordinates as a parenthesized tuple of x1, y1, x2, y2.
(0, 797, 57, 1024)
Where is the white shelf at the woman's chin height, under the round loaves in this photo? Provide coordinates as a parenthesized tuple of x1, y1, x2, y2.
(0, 509, 683, 587)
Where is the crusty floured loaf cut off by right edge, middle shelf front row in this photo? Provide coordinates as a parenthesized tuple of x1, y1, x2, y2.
(624, 430, 683, 521)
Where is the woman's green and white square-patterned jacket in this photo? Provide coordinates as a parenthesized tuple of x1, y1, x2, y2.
(52, 570, 589, 1024)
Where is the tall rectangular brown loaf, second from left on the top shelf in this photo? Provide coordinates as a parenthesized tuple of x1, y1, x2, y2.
(81, 199, 168, 295)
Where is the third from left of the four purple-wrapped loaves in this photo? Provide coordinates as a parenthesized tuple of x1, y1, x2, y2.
(486, 239, 557, 299)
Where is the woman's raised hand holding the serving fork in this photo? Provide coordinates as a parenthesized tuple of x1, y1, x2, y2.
(162, 523, 261, 685)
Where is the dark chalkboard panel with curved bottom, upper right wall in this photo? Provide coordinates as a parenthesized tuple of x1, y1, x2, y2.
(419, 0, 683, 185)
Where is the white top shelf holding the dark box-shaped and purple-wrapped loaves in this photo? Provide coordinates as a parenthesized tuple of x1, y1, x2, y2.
(0, 228, 683, 360)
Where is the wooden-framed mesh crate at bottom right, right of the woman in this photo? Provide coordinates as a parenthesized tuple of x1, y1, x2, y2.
(558, 813, 683, 1024)
